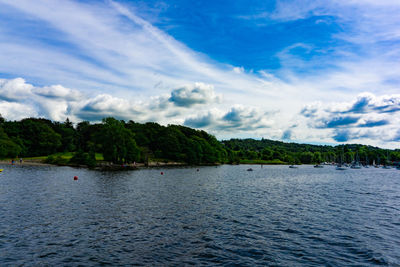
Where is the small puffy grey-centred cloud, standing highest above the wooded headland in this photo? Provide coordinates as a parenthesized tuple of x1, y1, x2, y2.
(169, 83, 221, 107)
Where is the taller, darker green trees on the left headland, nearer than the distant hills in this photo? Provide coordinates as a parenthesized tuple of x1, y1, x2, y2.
(0, 117, 226, 165)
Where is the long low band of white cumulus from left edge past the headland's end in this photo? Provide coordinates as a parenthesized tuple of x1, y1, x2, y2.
(0, 78, 279, 138)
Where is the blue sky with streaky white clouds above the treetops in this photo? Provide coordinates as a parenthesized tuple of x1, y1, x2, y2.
(0, 0, 400, 148)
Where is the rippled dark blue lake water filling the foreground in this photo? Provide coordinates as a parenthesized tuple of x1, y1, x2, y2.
(0, 166, 400, 266)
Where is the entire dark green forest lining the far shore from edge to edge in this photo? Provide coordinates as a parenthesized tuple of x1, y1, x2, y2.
(0, 116, 400, 166)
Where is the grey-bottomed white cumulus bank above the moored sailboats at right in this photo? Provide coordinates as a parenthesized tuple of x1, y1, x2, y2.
(300, 93, 400, 146)
